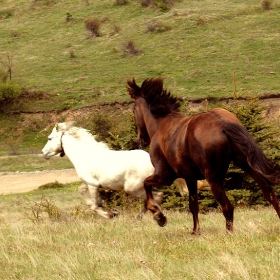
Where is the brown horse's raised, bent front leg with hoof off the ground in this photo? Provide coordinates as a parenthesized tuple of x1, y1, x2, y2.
(144, 175, 167, 227)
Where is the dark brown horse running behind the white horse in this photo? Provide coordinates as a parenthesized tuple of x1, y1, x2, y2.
(127, 78, 280, 234)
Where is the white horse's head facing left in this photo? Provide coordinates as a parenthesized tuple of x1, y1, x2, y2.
(42, 123, 71, 159)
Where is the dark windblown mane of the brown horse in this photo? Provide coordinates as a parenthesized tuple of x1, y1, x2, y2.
(128, 77, 181, 117)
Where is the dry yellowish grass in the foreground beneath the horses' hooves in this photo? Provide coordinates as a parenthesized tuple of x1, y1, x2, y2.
(0, 184, 280, 280)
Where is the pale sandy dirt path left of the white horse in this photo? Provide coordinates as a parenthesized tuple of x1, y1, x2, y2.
(0, 169, 79, 195)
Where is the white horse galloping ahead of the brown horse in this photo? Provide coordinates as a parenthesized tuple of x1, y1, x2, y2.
(42, 123, 163, 218)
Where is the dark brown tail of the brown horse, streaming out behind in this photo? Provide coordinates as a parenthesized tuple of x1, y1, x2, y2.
(223, 123, 280, 185)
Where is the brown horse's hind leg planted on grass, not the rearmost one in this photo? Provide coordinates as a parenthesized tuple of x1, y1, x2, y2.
(209, 182, 234, 231)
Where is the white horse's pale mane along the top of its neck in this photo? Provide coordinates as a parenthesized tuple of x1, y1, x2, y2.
(60, 123, 109, 149)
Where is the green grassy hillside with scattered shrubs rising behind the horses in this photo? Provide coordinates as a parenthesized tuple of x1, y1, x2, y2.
(0, 0, 280, 153)
